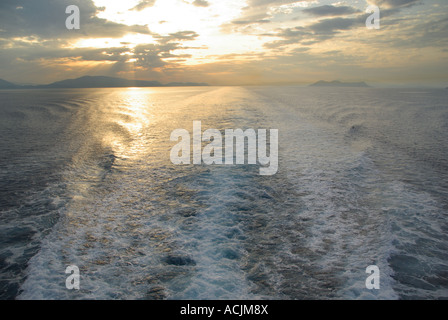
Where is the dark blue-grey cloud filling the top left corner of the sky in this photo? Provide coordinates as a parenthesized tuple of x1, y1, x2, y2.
(0, 0, 150, 39)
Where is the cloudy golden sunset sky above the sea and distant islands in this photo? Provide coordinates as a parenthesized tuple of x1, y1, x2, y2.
(0, 0, 448, 87)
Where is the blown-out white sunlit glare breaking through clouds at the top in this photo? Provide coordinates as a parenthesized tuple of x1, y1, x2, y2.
(73, 0, 263, 65)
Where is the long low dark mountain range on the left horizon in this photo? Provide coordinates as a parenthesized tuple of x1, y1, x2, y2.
(0, 76, 208, 89)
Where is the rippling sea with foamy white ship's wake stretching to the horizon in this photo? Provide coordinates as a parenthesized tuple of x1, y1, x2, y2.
(0, 86, 448, 300)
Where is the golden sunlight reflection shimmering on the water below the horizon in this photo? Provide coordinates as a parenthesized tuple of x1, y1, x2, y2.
(100, 87, 234, 165)
